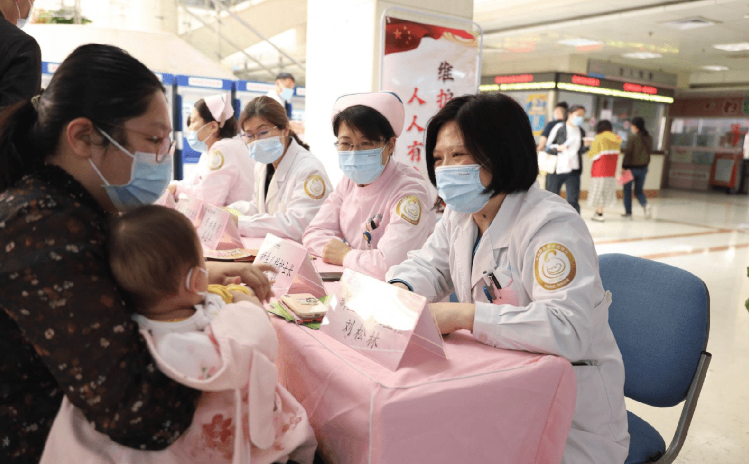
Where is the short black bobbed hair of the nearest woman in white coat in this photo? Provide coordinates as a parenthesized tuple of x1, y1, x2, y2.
(425, 92, 538, 195)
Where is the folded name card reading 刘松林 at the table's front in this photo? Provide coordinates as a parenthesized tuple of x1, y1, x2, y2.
(320, 269, 447, 370)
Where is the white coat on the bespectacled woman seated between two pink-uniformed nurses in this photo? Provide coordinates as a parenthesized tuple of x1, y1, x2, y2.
(230, 138, 331, 242)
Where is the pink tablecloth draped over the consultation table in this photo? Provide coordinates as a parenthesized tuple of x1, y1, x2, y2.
(273, 317, 576, 464)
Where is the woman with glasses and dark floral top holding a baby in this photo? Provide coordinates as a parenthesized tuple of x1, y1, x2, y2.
(0, 44, 271, 463)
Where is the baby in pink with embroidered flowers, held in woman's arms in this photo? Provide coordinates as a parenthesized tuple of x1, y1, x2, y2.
(41, 206, 317, 464)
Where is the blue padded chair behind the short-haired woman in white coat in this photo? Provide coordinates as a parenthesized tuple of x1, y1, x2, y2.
(599, 253, 712, 464)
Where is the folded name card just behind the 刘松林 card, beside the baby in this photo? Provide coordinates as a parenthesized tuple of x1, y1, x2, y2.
(255, 234, 327, 298)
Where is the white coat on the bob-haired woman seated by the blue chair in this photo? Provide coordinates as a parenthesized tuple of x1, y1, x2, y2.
(386, 185, 629, 464)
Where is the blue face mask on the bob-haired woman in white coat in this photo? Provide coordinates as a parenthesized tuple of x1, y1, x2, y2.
(434, 164, 492, 213)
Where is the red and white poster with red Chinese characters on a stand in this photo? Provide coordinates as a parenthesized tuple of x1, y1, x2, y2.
(380, 12, 481, 195)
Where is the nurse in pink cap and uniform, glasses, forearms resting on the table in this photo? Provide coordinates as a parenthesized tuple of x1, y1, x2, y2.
(302, 92, 436, 279)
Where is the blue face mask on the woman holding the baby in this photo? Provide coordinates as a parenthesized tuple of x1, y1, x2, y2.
(88, 129, 172, 211)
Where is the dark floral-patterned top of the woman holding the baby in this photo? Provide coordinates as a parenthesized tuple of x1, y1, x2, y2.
(0, 165, 200, 463)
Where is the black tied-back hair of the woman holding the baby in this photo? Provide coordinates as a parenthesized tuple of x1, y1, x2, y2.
(0, 44, 164, 192)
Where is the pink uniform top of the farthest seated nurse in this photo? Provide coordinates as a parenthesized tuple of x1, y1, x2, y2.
(175, 138, 255, 206)
